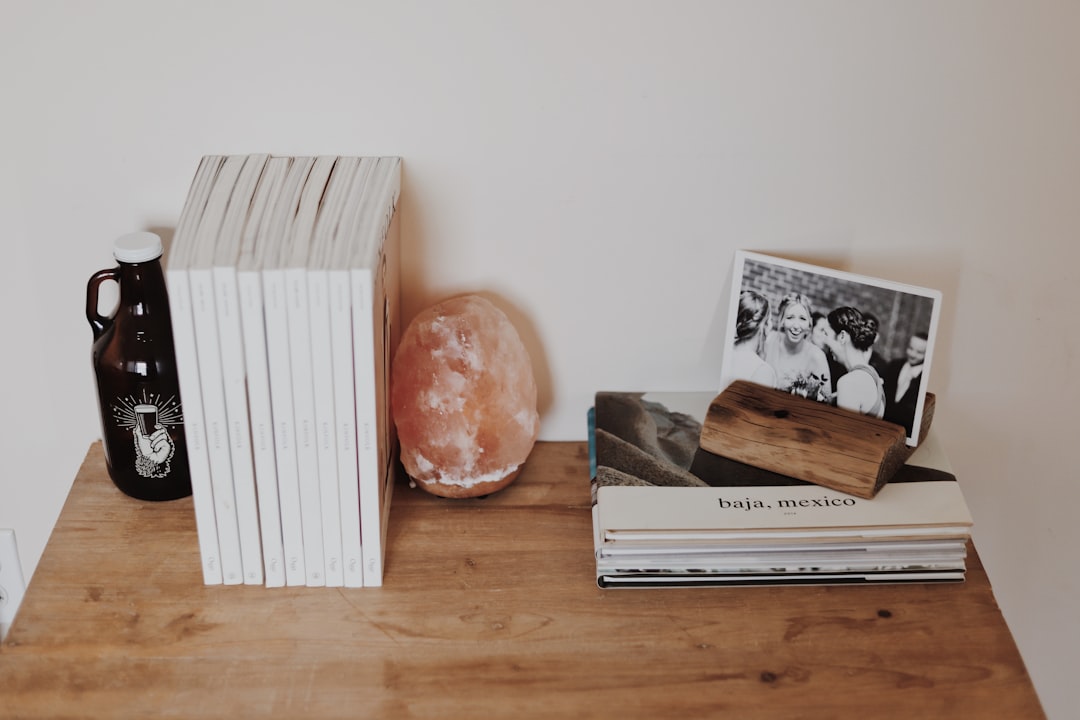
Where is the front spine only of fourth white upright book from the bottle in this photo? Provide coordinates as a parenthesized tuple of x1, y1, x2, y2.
(237, 271, 285, 587)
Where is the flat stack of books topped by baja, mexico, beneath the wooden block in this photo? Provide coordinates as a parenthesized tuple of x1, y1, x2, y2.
(590, 392, 972, 587)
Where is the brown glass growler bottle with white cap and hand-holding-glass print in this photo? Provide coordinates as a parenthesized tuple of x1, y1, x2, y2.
(86, 232, 191, 500)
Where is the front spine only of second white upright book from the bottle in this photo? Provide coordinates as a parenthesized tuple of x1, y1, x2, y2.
(188, 268, 244, 585)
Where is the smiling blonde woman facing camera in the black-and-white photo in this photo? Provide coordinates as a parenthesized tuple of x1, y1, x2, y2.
(765, 293, 833, 403)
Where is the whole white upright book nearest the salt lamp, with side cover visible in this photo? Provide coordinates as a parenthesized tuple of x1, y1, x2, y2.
(350, 158, 401, 586)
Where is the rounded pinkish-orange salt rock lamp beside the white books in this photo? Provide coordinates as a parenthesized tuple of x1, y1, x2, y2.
(390, 295, 540, 498)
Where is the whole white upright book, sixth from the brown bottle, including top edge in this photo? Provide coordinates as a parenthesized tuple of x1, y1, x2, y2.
(283, 155, 335, 587)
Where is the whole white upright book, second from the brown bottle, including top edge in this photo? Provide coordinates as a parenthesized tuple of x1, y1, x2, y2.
(188, 155, 244, 585)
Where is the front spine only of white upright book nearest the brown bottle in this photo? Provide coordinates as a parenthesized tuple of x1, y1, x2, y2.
(165, 270, 224, 585)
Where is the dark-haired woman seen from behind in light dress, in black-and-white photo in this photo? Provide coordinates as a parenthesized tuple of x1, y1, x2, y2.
(826, 308, 885, 418)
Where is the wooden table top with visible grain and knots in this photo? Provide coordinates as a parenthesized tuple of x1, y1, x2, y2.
(0, 443, 1043, 720)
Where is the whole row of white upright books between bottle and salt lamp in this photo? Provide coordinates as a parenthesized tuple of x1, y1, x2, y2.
(165, 154, 401, 587)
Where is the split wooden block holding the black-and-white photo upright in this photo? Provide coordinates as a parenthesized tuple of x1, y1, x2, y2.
(701, 380, 934, 499)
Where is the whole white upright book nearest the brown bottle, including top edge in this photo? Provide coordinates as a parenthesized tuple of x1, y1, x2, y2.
(165, 155, 224, 585)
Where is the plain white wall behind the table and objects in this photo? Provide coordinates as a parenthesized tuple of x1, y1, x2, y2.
(0, 0, 1080, 718)
